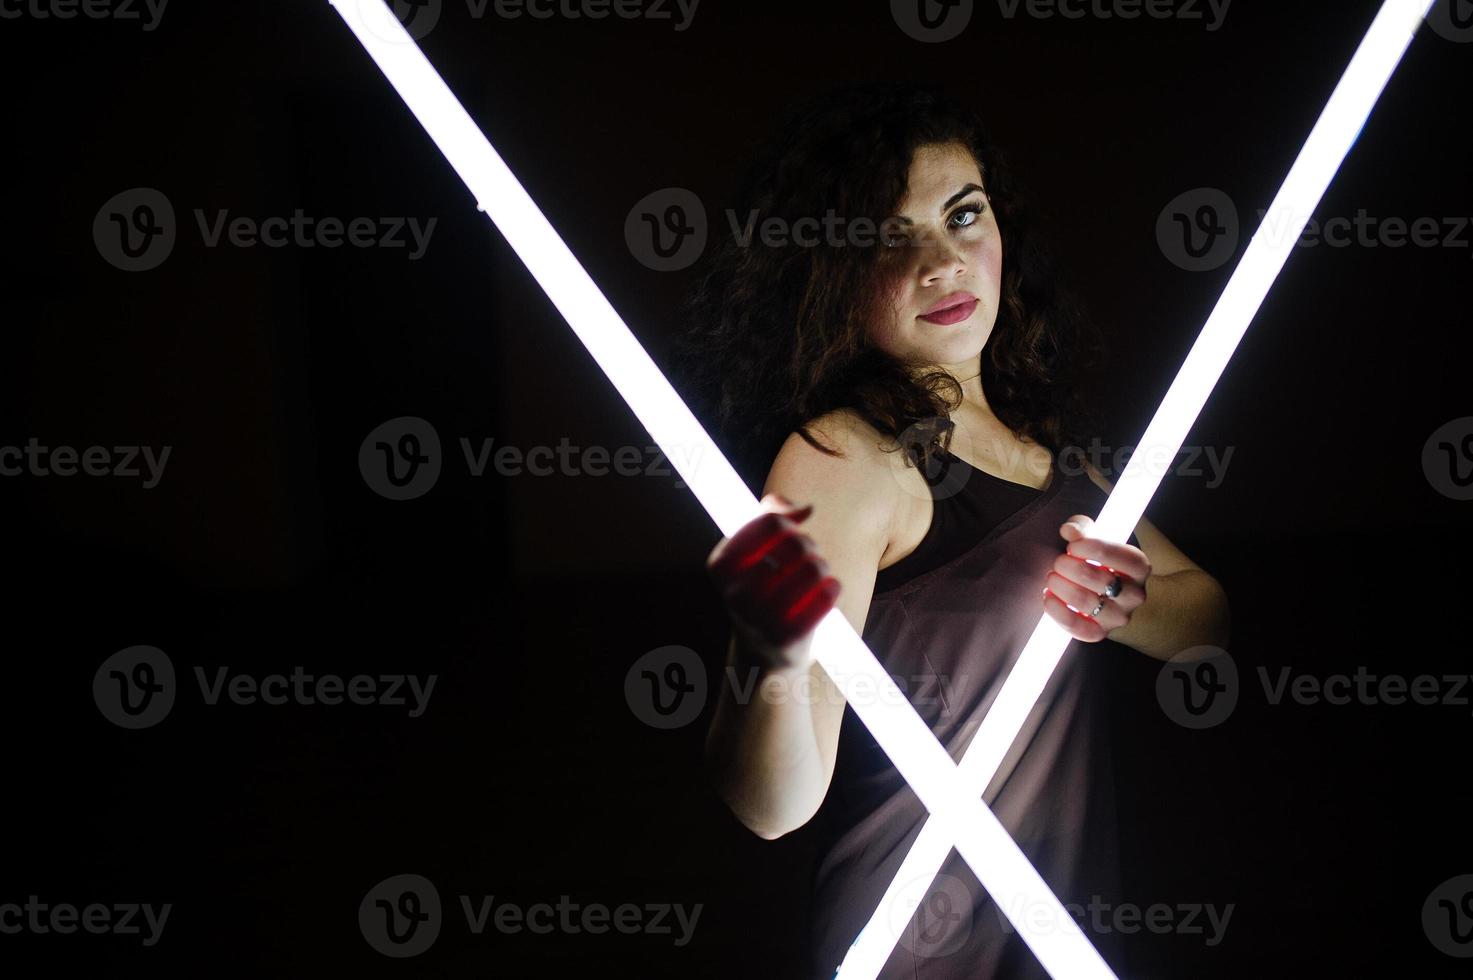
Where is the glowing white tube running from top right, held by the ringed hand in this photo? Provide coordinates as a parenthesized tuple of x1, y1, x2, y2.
(838, 0, 1432, 980)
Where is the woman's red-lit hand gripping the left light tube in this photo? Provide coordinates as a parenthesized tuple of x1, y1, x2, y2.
(706, 494, 840, 671)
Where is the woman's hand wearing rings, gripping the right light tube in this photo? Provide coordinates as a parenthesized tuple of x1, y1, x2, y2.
(1043, 514, 1150, 643)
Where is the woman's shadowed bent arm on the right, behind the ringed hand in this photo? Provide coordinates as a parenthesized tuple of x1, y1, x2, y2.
(1084, 463, 1231, 660)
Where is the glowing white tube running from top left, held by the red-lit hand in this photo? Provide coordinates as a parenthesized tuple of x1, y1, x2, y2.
(333, 0, 1114, 980)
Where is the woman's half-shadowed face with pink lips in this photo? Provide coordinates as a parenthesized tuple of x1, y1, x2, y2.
(871, 143, 1003, 379)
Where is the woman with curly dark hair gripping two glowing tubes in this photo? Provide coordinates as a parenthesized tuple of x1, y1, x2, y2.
(682, 85, 1228, 979)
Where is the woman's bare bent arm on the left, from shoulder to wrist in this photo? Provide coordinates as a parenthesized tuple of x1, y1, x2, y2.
(706, 409, 897, 840)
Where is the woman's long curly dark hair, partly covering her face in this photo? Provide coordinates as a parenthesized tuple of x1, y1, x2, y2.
(675, 83, 1102, 488)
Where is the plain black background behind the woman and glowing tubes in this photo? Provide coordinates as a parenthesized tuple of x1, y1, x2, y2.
(0, 0, 1473, 979)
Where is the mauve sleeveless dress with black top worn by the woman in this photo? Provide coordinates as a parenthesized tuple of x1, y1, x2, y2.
(810, 452, 1139, 980)
